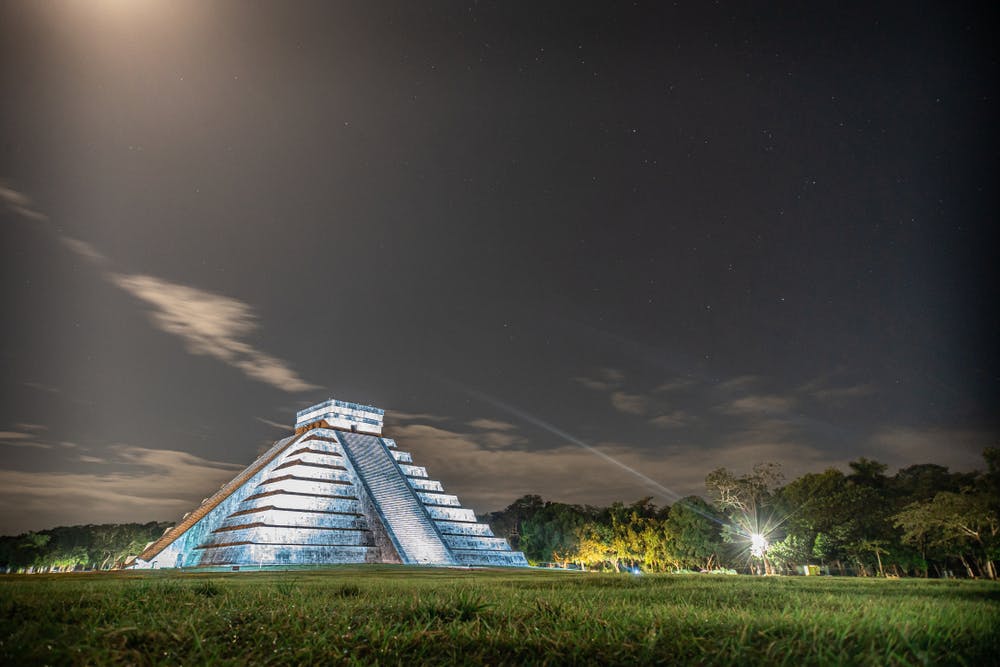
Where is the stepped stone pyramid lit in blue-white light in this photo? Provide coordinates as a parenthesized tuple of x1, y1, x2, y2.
(132, 399, 528, 569)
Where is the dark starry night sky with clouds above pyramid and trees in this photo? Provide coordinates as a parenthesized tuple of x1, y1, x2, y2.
(0, 0, 1000, 533)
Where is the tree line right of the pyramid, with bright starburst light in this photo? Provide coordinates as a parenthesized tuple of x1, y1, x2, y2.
(484, 448, 1000, 579)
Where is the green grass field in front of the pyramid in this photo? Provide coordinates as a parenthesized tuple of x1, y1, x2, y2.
(0, 566, 1000, 665)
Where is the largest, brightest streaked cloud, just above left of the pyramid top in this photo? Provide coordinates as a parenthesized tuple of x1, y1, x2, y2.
(108, 273, 319, 392)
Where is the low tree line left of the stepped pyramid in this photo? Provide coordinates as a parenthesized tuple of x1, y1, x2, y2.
(0, 521, 171, 572)
